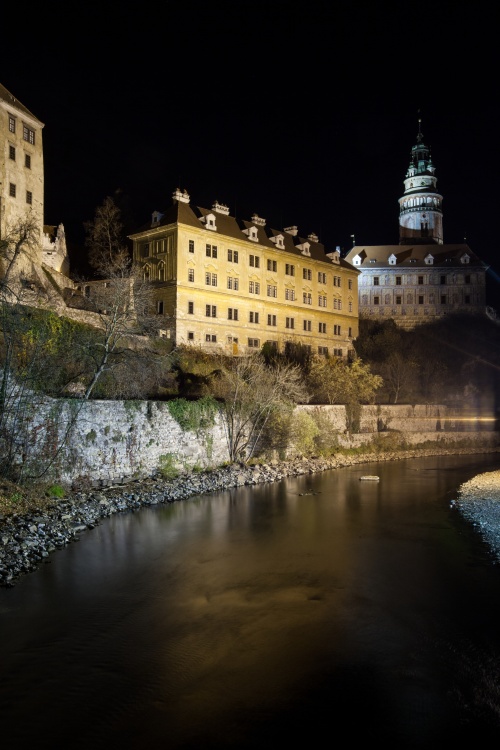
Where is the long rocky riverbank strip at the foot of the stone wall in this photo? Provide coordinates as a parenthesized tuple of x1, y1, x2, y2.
(0, 446, 500, 587)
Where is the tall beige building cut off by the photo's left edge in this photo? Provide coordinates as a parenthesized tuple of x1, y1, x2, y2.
(0, 84, 69, 282)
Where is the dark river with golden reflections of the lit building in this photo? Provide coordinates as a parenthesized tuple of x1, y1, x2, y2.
(0, 454, 500, 750)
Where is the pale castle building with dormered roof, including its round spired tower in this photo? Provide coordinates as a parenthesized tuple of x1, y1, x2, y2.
(346, 121, 487, 328)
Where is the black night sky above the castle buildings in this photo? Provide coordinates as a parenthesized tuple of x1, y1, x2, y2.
(0, 0, 500, 307)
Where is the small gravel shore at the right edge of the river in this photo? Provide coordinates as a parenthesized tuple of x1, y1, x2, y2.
(453, 470, 500, 561)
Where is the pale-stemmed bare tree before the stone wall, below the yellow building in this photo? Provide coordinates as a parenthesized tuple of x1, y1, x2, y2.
(209, 354, 308, 461)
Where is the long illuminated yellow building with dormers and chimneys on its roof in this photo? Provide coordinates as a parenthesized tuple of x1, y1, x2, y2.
(130, 190, 359, 357)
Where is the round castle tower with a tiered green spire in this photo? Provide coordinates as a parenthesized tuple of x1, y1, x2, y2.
(399, 119, 443, 245)
